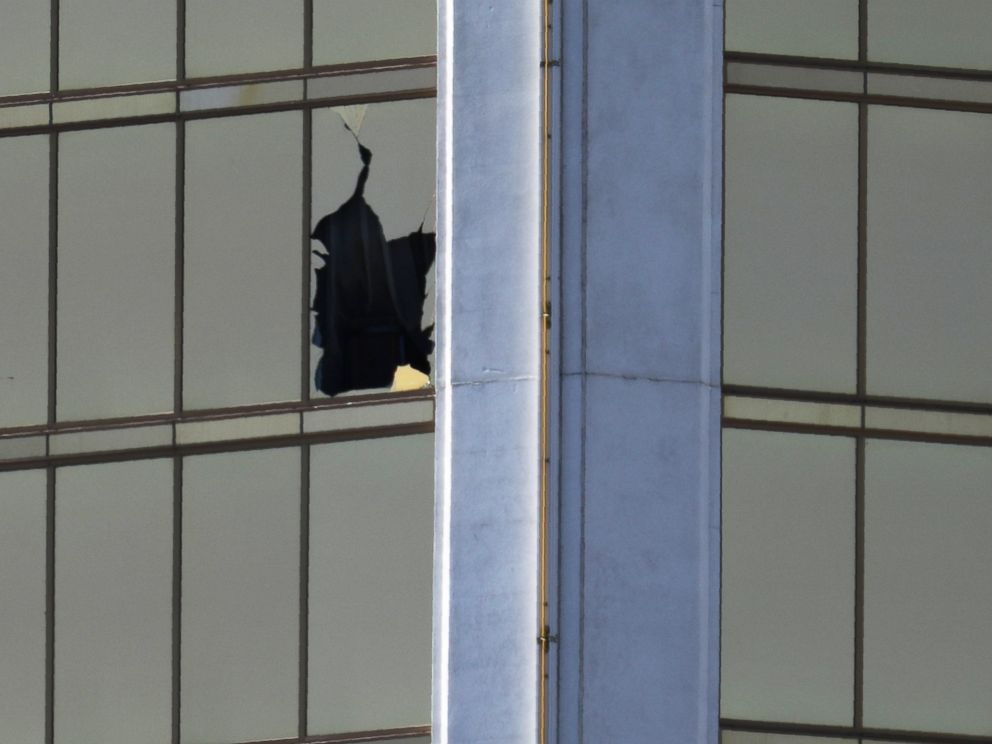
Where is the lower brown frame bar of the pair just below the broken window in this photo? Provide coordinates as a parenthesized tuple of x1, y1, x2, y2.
(0, 421, 434, 472)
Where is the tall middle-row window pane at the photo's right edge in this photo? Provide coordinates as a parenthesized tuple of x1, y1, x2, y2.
(868, 106, 992, 401)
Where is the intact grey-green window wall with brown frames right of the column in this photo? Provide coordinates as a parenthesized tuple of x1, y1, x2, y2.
(721, 0, 992, 744)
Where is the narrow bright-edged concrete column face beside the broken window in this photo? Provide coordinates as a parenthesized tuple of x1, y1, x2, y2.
(433, 0, 541, 744)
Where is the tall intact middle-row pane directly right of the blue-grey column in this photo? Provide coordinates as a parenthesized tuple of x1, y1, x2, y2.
(724, 95, 858, 392)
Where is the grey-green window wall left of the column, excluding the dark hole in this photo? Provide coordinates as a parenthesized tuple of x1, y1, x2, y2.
(0, 0, 436, 744)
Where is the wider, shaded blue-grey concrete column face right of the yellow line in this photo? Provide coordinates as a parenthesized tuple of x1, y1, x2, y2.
(556, 0, 722, 744)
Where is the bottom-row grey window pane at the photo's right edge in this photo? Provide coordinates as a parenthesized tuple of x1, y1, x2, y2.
(864, 441, 992, 736)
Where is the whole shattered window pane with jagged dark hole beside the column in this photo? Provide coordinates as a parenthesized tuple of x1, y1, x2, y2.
(311, 100, 435, 402)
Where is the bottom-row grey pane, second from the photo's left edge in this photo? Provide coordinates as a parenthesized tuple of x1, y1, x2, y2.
(55, 460, 172, 744)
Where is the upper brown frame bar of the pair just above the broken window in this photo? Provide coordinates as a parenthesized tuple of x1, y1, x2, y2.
(0, 55, 437, 108)
